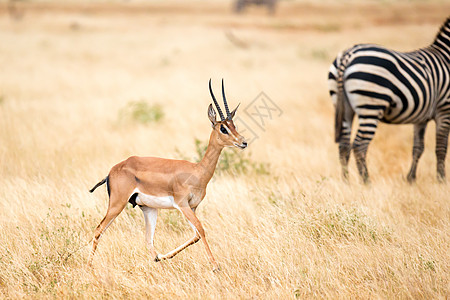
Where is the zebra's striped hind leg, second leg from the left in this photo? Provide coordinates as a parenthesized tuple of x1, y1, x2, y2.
(353, 115, 378, 184)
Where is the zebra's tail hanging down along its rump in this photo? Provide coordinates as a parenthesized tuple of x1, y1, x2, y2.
(334, 52, 350, 143)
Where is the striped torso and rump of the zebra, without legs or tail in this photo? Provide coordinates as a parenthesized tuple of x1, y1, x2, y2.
(329, 44, 449, 124)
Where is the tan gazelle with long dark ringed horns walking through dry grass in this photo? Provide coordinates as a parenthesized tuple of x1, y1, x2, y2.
(89, 79, 247, 270)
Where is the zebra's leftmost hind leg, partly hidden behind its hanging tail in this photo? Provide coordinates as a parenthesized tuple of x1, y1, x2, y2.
(339, 106, 355, 181)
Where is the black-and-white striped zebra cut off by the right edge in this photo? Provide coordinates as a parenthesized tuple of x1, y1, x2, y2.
(328, 17, 450, 183)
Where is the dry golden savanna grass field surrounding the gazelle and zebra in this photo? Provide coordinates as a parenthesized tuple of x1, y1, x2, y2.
(0, 0, 450, 299)
